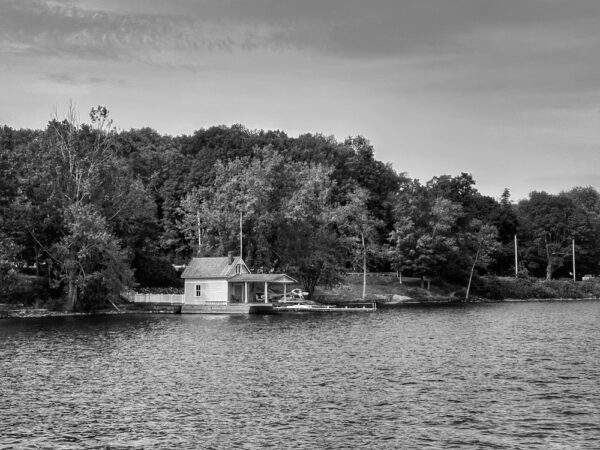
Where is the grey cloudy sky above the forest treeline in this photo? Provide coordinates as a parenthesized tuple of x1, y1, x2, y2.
(0, 0, 600, 200)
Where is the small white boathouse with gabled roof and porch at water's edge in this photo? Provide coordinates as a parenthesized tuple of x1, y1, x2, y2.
(181, 253, 296, 314)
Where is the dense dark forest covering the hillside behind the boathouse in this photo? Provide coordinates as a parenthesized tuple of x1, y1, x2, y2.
(0, 106, 600, 310)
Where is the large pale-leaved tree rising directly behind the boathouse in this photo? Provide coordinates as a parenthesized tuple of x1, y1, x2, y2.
(179, 147, 339, 295)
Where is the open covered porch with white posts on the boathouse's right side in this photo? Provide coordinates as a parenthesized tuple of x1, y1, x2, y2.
(227, 273, 297, 304)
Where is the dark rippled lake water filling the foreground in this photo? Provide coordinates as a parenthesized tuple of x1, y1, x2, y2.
(0, 302, 600, 449)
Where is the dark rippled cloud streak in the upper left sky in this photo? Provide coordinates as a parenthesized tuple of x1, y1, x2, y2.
(0, 1, 276, 61)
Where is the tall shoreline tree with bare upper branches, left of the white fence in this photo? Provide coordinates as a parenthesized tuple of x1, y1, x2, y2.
(20, 106, 132, 311)
